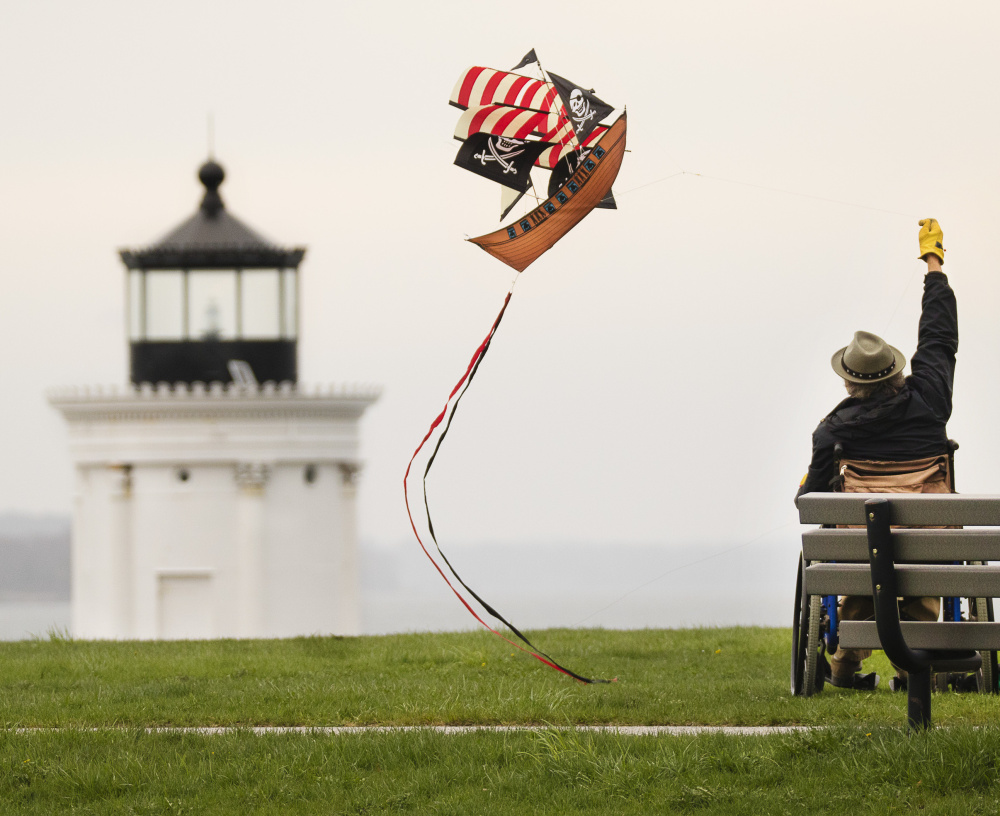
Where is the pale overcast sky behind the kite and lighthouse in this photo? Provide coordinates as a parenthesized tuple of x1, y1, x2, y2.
(0, 0, 1000, 628)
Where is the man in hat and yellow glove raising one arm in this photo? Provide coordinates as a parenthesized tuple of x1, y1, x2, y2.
(796, 218, 958, 690)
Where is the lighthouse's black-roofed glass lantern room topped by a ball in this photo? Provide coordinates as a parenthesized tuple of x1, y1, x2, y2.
(120, 161, 305, 383)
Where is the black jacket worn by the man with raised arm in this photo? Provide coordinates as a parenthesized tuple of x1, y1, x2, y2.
(796, 272, 958, 498)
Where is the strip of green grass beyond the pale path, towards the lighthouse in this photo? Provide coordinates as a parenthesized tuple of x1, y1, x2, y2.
(0, 628, 1000, 728)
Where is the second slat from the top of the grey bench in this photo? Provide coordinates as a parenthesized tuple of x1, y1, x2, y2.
(802, 529, 1000, 563)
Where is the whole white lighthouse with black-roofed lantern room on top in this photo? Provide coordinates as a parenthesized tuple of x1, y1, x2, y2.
(49, 160, 378, 639)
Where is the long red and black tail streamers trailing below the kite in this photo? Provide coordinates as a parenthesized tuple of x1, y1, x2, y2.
(403, 278, 613, 683)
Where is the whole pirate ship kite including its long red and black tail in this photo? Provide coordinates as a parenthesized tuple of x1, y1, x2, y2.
(403, 54, 625, 683)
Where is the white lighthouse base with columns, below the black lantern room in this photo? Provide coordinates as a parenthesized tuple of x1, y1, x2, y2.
(49, 383, 378, 639)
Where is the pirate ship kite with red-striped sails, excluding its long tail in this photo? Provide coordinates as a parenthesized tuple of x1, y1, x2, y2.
(449, 49, 626, 272)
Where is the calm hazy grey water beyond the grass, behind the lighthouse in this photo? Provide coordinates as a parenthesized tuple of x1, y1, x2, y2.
(0, 539, 799, 640)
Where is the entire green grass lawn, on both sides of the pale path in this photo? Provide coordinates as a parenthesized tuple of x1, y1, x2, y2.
(0, 628, 1000, 814)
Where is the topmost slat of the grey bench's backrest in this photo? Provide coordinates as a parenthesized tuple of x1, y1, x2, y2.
(798, 493, 1000, 526)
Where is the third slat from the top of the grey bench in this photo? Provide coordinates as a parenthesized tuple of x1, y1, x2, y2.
(804, 563, 1000, 598)
